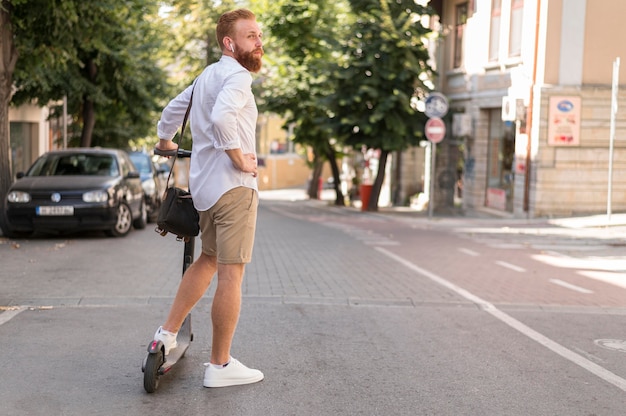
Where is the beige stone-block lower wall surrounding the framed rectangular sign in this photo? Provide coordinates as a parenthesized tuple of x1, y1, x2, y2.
(531, 87, 626, 217)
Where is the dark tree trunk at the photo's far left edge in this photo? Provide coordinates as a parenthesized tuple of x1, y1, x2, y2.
(0, 0, 18, 235)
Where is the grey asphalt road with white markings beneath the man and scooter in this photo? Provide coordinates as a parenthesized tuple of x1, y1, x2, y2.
(0, 193, 626, 416)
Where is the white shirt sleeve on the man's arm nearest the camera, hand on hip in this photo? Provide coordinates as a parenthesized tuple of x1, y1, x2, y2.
(211, 71, 252, 150)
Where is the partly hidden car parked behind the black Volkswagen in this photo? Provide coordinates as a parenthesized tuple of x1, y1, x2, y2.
(128, 152, 169, 222)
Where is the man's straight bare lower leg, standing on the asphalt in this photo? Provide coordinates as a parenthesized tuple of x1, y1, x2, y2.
(211, 264, 245, 364)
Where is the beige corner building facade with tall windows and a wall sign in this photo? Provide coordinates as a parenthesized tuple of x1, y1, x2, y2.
(430, 0, 626, 218)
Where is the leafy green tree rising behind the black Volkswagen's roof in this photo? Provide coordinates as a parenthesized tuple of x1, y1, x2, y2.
(12, 0, 167, 147)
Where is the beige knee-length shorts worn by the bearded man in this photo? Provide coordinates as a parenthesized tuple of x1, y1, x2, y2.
(200, 186, 259, 264)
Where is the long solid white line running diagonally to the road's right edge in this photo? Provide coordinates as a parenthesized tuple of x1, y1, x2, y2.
(376, 247, 626, 391)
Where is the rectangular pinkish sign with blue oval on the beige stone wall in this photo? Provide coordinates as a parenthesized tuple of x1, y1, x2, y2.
(548, 96, 581, 146)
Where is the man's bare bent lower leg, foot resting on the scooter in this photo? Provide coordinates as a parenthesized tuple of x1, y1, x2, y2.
(163, 253, 217, 333)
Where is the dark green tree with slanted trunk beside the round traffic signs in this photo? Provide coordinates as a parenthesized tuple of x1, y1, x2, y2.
(327, 0, 433, 211)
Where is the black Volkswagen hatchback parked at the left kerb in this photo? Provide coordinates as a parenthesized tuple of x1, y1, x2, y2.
(5, 148, 147, 237)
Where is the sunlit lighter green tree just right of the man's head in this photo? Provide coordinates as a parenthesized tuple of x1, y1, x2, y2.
(260, 0, 349, 205)
